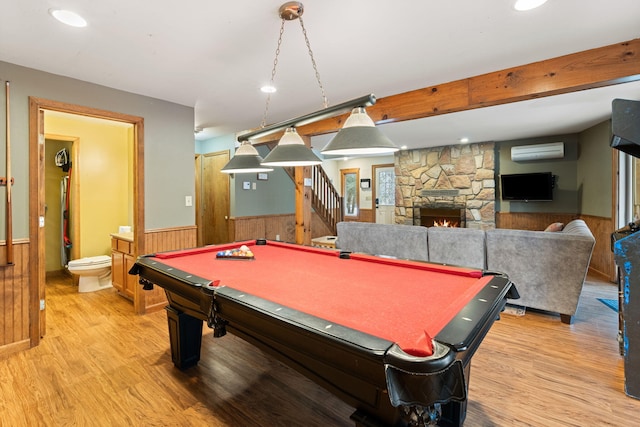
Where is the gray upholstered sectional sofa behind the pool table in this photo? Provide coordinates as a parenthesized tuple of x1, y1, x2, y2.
(336, 219, 595, 323)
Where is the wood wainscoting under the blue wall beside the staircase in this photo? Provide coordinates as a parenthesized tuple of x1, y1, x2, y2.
(229, 212, 334, 242)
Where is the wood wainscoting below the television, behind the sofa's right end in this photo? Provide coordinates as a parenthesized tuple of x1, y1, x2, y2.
(496, 212, 616, 282)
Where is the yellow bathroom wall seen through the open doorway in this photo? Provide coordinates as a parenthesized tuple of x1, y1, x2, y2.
(45, 113, 133, 257)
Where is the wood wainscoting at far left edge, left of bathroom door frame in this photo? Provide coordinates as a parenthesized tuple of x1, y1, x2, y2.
(0, 240, 30, 357)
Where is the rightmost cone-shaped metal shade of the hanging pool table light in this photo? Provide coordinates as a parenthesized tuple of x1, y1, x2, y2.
(320, 107, 399, 156)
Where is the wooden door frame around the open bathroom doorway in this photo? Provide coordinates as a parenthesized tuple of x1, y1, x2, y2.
(29, 96, 144, 347)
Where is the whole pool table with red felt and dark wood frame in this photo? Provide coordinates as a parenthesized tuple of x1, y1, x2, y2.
(130, 240, 517, 426)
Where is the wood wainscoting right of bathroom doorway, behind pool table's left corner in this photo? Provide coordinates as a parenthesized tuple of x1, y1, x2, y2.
(139, 225, 198, 314)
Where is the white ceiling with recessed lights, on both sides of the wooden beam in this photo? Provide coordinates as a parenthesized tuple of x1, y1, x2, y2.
(0, 0, 640, 148)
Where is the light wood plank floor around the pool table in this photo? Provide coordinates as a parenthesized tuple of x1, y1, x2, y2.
(0, 272, 640, 427)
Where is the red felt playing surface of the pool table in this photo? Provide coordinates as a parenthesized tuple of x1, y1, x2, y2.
(156, 241, 491, 356)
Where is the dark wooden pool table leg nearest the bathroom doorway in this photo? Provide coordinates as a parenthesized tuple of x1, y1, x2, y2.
(165, 306, 202, 369)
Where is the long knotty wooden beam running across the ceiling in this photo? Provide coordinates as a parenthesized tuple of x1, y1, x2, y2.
(249, 39, 640, 143)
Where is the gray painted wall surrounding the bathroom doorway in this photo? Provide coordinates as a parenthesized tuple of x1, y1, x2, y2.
(0, 61, 195, 239)
